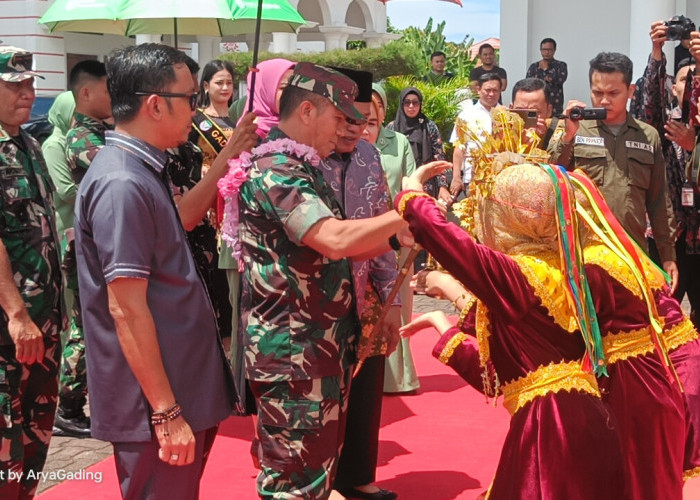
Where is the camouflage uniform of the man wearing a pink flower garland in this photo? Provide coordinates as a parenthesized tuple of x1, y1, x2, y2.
(240, 124, 359, 498)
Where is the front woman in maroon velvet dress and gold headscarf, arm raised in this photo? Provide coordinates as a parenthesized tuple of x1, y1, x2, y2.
(396, 165, 624, 500)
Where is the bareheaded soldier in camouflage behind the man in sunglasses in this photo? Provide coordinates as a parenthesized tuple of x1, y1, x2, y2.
(54, 60, 112, 437)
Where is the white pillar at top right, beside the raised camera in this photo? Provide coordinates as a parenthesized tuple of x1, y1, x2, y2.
(629, 0, 676, 82)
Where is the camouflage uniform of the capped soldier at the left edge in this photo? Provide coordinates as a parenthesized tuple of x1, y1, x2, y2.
(0, 124, 61, 498)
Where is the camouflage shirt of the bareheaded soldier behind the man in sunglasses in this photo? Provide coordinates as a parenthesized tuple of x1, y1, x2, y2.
(66, 113, 109, 184)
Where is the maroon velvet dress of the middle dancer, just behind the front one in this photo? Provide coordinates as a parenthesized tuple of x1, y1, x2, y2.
(584, 245, 686, 500)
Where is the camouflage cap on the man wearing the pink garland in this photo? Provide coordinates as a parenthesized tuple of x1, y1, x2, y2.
(289, 62, 367, 122)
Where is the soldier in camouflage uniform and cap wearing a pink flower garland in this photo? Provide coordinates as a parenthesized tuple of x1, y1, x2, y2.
(239, 63, 405, 499)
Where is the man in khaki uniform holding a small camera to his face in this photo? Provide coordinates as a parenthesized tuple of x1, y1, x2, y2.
(548, 52, 678, 290)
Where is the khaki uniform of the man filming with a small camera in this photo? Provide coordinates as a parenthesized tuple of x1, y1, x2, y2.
(548, 114, 676, 261)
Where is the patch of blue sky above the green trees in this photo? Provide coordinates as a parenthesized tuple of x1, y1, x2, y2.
(386, 0, 501, 42)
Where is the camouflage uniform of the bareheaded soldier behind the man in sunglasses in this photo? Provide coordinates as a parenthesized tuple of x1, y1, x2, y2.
(58, 113, 109, 418)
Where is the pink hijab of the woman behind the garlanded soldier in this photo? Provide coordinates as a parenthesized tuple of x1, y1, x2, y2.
(238, 59, 296, 139)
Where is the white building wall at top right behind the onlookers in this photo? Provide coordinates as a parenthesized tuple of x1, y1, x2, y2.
(500, 0, 700, 107)
